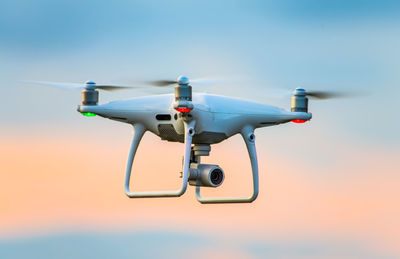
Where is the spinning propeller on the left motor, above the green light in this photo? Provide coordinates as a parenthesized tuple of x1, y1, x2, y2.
(23, 80, 140, 91)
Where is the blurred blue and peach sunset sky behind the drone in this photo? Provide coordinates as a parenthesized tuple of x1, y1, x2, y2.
(0, 0, 400, 258)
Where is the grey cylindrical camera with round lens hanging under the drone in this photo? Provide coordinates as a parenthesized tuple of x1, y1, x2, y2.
(189, 163, 225, 187)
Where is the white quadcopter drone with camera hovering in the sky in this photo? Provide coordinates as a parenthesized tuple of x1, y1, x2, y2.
(31, 76, 337, 204)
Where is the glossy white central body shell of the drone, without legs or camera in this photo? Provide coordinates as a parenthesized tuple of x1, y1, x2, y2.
(78, 93, 311, 145)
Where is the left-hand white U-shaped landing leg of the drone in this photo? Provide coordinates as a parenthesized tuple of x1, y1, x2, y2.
(125, 121, 195, 198)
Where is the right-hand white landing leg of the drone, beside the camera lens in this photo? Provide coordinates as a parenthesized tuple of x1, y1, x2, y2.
(196, 127, 258, 203)
